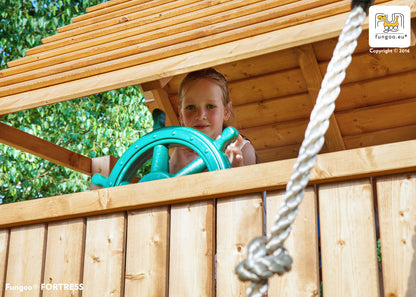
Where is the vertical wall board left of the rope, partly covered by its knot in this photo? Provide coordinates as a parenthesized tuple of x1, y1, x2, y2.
(216, 193, 263, 297)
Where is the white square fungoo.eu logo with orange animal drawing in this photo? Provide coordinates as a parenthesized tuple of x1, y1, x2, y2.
(368, 6, 410, 47)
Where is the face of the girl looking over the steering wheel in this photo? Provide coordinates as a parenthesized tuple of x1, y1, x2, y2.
(179, 79, 231, 139)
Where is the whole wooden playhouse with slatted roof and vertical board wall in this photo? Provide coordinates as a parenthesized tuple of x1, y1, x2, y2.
(0, 0, 416, 297)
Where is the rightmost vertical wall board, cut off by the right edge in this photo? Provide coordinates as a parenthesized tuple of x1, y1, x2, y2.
(376, 173, 416, 297)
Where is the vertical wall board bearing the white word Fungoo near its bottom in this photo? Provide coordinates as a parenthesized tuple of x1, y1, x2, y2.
(4, 224, 46, 297)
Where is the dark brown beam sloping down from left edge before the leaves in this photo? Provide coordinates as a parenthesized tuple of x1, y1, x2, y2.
(0, 123, 91, 175)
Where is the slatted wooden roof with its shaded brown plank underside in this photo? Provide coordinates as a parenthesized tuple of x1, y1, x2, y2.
(0, 0, 416, 172)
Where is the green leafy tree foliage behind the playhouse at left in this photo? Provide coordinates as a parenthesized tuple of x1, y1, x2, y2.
(0, 0, 152, 203)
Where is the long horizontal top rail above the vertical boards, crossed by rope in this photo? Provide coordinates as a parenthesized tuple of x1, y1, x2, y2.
(0, 140, 416, 228)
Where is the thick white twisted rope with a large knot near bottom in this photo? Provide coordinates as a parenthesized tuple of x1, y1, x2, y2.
(236, 0, 372, 297)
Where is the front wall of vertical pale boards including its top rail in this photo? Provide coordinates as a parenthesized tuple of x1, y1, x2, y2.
(0, 140, 416, 297)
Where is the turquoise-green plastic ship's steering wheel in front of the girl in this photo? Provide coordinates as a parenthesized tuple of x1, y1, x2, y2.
(92, 109, 238, 188)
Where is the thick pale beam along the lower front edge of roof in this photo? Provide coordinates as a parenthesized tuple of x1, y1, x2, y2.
(0, 0, 416, 114)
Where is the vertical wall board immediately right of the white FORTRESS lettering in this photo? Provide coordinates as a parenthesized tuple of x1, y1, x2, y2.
(82, 212, 126, 297)
